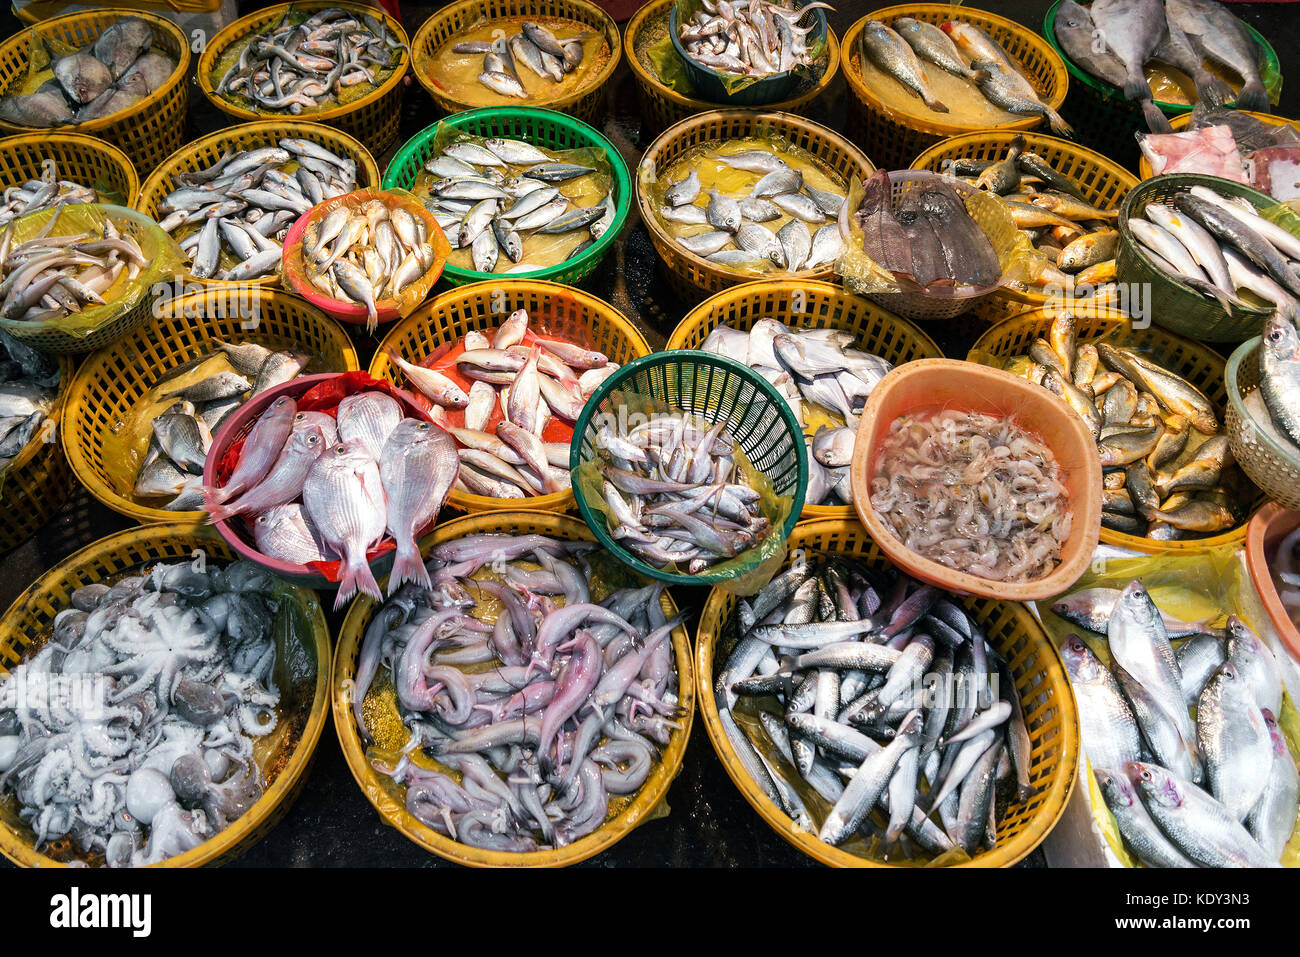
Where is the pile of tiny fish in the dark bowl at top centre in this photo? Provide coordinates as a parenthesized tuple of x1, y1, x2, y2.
(677, 0, 835, 77)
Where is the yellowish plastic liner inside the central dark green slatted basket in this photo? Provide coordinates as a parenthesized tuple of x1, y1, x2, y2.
(573, 390, 794, 596)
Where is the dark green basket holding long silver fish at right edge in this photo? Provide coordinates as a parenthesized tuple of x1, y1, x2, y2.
(1115, 173, 1277, 342)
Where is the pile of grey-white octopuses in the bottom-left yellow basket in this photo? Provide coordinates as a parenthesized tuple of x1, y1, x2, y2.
(0, 562, 281, 867)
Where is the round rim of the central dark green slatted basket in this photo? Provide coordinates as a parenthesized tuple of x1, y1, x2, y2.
(569, 348, 809, 585)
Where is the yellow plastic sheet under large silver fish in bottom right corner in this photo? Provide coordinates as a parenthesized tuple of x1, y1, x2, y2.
(1036, 544, 1300, 867)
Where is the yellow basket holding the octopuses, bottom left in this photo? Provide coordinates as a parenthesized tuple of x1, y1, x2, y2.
(0, 521, 330, 867)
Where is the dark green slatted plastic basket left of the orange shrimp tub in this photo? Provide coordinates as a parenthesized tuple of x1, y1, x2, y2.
(569, 348, 809, 586)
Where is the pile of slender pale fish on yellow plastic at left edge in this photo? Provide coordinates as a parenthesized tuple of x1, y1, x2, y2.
(0, 205, 147, 322)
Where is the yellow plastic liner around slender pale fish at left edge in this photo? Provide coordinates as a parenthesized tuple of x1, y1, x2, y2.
(0, 203, 185, 339)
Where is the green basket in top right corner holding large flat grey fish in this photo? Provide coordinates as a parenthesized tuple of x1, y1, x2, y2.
(1043, 0, 1282, 170)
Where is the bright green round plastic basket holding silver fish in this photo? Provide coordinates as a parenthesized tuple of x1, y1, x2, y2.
(384, 107, 632, 286)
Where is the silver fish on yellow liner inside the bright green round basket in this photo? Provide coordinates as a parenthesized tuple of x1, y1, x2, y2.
(413, 137, 618, 274)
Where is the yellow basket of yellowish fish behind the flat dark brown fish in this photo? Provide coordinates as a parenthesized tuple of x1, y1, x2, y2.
(911, 130, 1138, 322)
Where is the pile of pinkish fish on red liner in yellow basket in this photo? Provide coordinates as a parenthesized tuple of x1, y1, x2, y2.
(389, 309, 608, 498)
